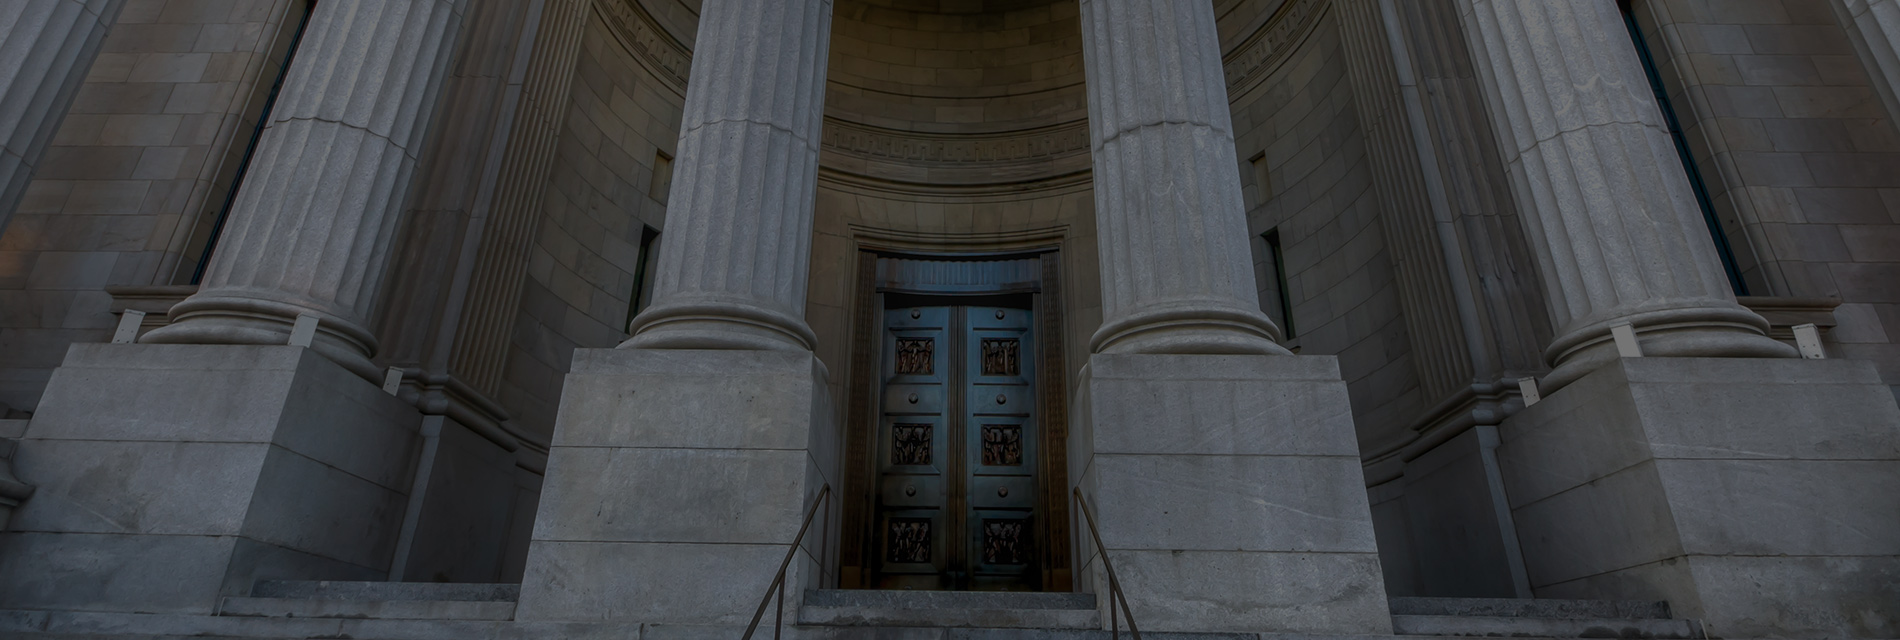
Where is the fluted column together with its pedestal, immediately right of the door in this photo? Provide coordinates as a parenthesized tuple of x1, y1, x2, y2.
(1068, 0, 1393, 634)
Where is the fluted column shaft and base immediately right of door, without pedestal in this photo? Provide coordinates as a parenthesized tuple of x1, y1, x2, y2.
(1081, 0, 1288, 353)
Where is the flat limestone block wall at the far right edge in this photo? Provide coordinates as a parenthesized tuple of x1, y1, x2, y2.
(1634, 0, 1900, 396)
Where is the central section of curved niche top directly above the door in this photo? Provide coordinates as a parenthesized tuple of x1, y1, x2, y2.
(823, 0, 1089, 186)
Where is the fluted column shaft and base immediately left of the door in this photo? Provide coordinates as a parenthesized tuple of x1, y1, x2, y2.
(621, 0, 832, 351)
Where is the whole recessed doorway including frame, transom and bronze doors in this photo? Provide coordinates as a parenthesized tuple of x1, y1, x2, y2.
(842, 253, 1070, 591)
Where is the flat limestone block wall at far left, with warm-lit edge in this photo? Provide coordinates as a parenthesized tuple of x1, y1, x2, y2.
(0, 0, 304, 410)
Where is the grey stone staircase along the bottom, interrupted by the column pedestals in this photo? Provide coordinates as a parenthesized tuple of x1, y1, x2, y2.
(0, 581, 1704, 640)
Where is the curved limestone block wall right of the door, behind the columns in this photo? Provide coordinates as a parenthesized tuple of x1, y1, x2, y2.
(1227, 2, 1425, 450)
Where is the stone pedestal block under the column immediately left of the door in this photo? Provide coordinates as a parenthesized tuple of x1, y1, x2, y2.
(515, 349, 840, 625)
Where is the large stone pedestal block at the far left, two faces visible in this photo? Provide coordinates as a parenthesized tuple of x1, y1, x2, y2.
(0, 344, 422, 613)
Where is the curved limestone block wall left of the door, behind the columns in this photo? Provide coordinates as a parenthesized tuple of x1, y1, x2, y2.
(500, 9, 692, 433)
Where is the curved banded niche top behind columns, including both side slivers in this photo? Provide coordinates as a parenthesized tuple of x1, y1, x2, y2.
(595, 0, 1332, 186)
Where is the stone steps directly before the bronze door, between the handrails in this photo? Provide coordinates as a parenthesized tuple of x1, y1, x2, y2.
(798, 589, 1102, 631)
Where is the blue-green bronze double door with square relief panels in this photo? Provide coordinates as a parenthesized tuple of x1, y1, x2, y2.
(872, 306, 1041, 591)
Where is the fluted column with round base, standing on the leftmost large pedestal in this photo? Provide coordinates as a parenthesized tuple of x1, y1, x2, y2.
(141, 0, 467, 380)
